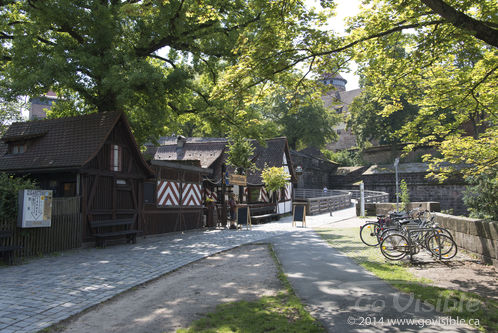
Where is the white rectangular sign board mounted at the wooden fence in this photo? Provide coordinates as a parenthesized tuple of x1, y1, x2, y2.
(17, 190, 52, 228)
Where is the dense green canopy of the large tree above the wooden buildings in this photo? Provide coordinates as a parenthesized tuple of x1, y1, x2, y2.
(0, 0, 334, 142)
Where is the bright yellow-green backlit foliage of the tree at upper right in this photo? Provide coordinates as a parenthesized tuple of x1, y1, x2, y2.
(340, 0, 498, 179)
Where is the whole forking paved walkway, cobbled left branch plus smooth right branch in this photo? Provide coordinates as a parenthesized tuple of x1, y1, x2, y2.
(0, 209, 474, 333)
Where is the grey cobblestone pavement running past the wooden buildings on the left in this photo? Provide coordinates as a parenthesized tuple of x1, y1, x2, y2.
(0, 209, 354, 333)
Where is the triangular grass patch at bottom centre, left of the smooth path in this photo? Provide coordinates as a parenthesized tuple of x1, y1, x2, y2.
(177, 244, 325, 333)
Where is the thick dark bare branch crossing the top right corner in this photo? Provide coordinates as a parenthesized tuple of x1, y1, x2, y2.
(420, 0, 498, 47)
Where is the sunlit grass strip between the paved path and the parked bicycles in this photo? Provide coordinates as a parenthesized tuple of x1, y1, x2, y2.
(316, 228, 498, 332)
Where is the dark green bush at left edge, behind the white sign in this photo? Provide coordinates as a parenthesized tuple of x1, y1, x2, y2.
(0, 173, 37, 220)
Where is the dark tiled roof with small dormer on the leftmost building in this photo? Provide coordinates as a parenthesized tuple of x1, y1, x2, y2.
(0, 112, 121, 171)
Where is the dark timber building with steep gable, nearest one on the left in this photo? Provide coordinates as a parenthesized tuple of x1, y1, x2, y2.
(0, 112, 154, 241)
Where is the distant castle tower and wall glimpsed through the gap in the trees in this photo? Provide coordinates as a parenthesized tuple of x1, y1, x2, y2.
(321, 74, 361, 151)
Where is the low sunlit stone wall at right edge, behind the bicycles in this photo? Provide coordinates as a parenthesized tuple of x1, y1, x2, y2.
(436, 213, 498, 267)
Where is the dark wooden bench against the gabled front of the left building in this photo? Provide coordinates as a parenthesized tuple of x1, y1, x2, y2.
(90, 219, 138, 247)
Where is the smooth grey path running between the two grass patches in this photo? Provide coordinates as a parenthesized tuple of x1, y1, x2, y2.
(271, 226, 478, 332)
